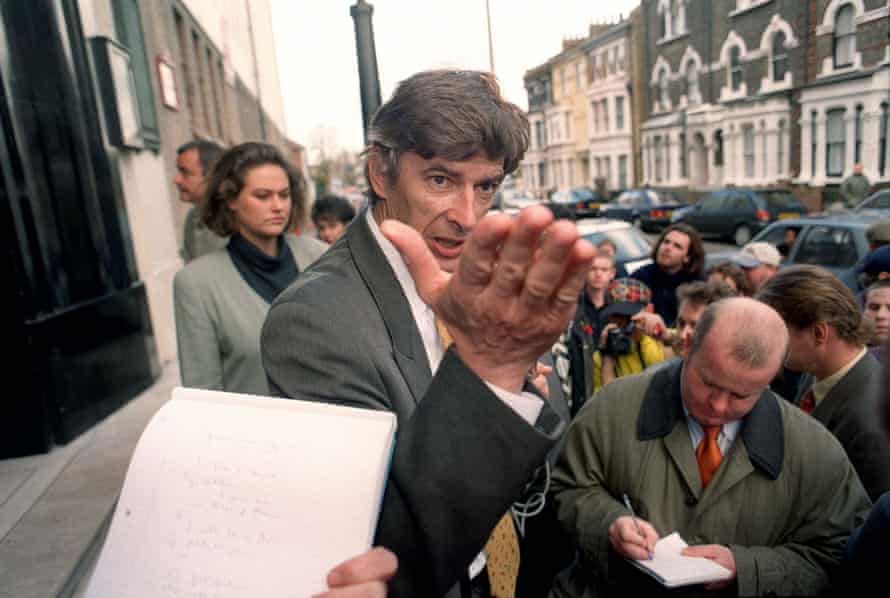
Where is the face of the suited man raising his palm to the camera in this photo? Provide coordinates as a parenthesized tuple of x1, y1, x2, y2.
(372, 152, 504, 272)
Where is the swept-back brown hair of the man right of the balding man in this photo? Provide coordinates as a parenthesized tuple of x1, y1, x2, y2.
(754, 265, 872, 345)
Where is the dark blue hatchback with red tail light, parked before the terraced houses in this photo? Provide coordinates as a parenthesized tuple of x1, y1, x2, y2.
(678, 187, 808, 247)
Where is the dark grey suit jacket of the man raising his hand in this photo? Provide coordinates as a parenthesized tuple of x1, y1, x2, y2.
(261, 213, 562, 597)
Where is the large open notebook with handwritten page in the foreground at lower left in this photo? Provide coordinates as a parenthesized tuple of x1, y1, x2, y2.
(86, 388, 396, 598)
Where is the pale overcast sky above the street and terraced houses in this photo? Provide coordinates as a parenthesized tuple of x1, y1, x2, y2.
(270, 0, 639, 161)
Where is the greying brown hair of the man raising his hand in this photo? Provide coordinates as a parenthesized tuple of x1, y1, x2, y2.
(364, 69, 529, 205)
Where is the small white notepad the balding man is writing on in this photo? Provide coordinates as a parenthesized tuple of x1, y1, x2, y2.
(629, 532, 732, 588)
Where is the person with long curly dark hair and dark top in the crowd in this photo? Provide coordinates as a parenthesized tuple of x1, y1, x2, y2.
(631, 223, 705, 325)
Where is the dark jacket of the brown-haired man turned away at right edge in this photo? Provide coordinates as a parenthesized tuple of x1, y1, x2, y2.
(795, 353, 890, 501)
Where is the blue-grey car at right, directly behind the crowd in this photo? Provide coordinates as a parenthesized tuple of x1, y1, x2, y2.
(705, 211, 882, 292)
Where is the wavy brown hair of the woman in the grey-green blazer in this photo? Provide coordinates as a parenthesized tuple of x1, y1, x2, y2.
(201, 142, 306, 237)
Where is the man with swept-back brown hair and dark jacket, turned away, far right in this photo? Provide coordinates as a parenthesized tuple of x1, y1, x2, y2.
(755, 265, 890, 500)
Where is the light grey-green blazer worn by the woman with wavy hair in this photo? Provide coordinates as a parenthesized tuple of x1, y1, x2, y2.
(173, 235, 327, 395)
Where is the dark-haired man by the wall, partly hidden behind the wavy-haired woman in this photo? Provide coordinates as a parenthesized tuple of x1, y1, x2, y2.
(173, 140, 227, 263)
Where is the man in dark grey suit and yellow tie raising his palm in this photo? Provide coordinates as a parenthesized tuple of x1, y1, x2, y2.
(261, 70, 595, 598)
